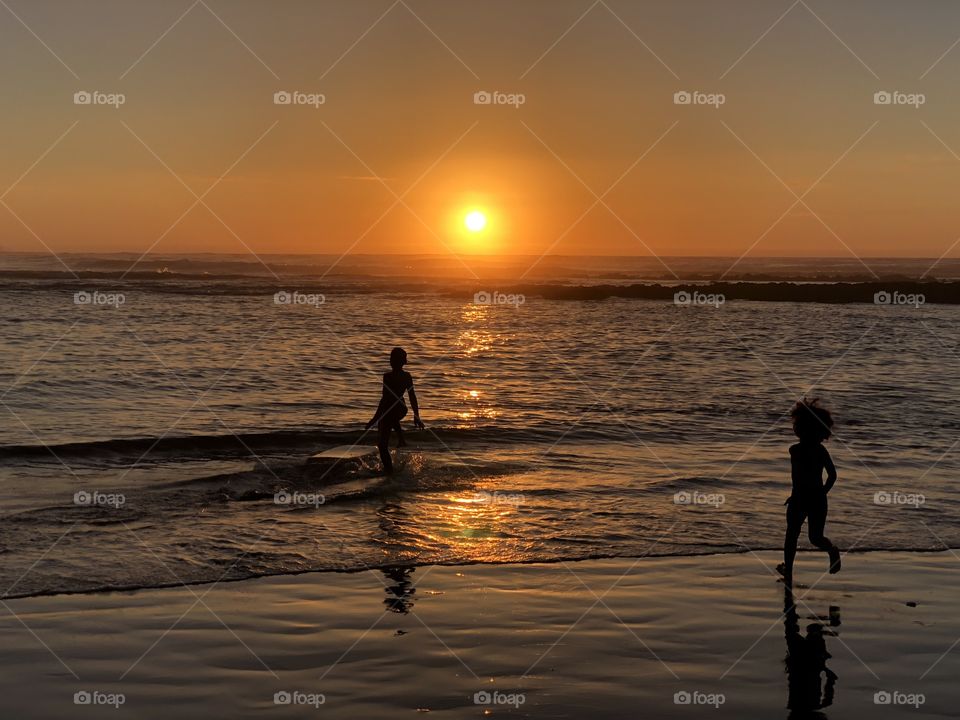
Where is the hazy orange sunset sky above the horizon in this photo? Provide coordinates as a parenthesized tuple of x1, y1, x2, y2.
(0, 0, 960, 258)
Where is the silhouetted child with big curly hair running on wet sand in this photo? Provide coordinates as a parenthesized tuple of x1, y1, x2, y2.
(777, 399, 840, 582)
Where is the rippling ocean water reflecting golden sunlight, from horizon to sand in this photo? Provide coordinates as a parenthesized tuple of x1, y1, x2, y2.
(0, 255, 960, 597)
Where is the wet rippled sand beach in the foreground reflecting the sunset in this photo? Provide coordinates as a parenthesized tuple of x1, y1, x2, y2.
(0, 552, 960, 719)
